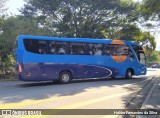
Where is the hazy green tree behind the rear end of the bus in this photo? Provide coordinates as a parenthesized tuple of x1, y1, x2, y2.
(0, 17, 47, 74)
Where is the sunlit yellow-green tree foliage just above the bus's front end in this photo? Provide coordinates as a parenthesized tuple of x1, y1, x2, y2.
(102, 24, 156, 53)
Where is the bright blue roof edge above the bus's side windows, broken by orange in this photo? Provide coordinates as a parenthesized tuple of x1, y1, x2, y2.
(17, 35, 138, 46)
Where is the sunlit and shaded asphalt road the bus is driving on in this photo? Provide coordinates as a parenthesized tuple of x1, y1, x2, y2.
(0, 69, 160, 118)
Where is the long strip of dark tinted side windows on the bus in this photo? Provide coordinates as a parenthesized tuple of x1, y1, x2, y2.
(24, 39, 129, 55)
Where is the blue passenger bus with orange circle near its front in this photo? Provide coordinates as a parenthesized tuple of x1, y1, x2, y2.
(16, 35, 146, 83)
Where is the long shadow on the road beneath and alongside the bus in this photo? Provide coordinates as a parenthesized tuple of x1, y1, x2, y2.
(0, 78, 146, 103)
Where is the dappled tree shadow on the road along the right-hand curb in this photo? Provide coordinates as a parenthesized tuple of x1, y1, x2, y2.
(121, 76, 158, 118)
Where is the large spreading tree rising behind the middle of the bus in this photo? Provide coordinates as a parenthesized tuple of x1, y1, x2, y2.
(21, 0, 136, 38)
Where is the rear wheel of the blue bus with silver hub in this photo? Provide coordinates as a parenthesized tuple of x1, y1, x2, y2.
(59, 71, 72, 84)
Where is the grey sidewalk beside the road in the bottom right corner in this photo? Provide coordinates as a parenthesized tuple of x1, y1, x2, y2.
(136, 77, 160, 118)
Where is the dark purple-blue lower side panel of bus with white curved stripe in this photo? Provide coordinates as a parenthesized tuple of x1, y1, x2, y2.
(20, 63, 117, 81)
